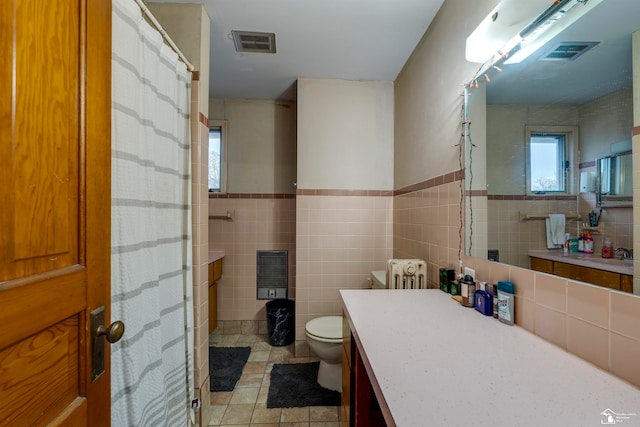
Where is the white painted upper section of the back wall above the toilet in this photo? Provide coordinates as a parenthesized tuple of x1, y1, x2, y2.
(298, 78, 393, 190)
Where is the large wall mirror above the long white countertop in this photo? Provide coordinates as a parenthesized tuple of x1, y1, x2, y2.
(465, 0, 640, 274)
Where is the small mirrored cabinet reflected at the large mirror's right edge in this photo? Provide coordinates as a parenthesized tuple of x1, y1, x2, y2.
(596, 153, 633, 208)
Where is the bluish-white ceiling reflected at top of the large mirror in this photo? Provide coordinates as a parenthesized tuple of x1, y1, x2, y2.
(487, 0, 640, 105)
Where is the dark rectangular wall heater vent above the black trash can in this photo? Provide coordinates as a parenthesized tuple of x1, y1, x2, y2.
(257, 251, 288, 299)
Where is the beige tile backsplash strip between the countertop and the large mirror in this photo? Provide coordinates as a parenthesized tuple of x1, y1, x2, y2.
(465, 258, 640, 387)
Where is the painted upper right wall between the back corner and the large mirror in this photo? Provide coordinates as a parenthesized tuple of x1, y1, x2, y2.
(394, 0, 498, 189)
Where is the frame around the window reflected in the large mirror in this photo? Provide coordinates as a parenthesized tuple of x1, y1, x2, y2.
(525, 125, 579, 196)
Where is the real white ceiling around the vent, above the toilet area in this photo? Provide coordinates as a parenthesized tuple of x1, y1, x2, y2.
(148, 0, 444, 99)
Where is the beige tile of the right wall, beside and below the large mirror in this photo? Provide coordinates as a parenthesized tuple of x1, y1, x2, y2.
(393, 175, 640, 387)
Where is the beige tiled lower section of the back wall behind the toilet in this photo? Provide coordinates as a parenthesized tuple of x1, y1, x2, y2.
(296, 194, 393, 340)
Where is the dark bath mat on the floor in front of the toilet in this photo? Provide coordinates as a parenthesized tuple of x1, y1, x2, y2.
(267, 362, 340, 408)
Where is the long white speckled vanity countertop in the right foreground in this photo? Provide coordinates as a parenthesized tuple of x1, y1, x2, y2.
(340, 289, 640, 427)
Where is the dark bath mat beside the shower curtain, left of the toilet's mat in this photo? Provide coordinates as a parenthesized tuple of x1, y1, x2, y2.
(209, 347, 251, 391)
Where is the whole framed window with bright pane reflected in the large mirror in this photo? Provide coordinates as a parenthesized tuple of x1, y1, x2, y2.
(526, 127, 577, 194)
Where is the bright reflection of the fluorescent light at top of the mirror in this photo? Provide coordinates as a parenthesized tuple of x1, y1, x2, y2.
(504, 0, 602, 64)
